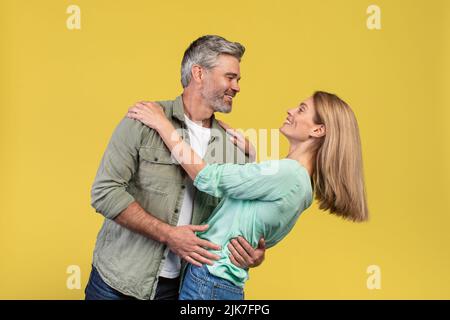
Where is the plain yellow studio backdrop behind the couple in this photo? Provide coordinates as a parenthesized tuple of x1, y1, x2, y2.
(0, 0, 450, 299)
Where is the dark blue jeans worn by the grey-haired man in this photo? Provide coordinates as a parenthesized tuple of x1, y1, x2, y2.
(84, 266, 180, 300)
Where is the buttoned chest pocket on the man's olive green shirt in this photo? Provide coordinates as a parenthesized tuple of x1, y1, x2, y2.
(136, 147, 183, 195)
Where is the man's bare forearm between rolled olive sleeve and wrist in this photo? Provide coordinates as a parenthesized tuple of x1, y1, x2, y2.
(114, 202, 171, 244)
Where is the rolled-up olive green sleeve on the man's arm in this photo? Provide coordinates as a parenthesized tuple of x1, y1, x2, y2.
(91, 118, 143, 219)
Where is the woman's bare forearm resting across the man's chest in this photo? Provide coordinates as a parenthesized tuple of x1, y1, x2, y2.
(157, 121, 206, 180)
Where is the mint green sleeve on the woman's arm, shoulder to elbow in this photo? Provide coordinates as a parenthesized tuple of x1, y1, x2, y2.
(194, 161, 295, 201)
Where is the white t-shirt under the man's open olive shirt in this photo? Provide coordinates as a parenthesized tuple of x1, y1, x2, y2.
(160, 115, 211, 279)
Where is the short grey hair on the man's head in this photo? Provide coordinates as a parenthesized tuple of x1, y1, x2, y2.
(181, 35, 245, 88)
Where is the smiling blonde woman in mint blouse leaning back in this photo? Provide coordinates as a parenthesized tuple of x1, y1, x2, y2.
(127, 92, 368, 300)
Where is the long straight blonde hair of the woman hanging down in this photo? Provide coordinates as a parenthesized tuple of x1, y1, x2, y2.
(312, 91, 369, 222)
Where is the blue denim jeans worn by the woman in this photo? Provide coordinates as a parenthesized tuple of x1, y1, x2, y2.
(179, 264, 244, 300)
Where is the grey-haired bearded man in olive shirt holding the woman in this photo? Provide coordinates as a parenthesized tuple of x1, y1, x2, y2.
(86, 36, 265, 299)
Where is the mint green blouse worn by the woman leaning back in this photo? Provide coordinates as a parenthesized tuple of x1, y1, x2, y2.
(194, 159, 313, 287)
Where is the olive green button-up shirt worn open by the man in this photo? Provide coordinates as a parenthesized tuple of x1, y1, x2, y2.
(91, 96, 248, 299)
